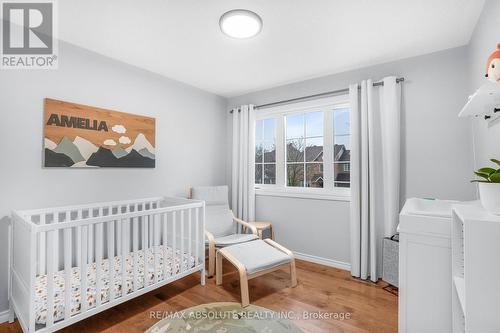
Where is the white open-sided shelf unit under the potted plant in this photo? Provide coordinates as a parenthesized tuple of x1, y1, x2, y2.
(451, 206, 500, 333)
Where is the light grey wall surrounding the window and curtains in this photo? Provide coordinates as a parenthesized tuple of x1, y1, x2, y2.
(226, 47, 475, 263)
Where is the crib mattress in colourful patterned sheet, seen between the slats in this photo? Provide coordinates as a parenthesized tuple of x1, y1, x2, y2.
(35, 245, 195, 324)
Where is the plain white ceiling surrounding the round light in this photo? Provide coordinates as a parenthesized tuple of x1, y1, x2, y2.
(58, 0, 484, 97)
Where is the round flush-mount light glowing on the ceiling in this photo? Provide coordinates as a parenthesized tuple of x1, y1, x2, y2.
(219, 9, 262, 39)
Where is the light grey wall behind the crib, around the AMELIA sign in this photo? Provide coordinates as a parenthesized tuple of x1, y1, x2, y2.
(0, 43, 226, 312)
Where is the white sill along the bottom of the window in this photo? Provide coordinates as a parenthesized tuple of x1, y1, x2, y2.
(255, 187, 351, 202)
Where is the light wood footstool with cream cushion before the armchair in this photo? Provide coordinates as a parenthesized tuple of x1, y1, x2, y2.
(216, 239, 297, 307)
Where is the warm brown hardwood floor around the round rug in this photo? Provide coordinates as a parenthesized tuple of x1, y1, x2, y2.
(0, 260, 398, 333)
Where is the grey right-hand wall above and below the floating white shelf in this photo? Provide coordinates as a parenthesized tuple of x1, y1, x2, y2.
(468, 0, 500, 168)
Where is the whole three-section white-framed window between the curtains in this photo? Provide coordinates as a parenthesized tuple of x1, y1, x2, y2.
(255, 96, 351, 197)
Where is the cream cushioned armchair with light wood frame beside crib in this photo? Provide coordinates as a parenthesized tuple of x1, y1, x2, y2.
(189, 186, 259, 277)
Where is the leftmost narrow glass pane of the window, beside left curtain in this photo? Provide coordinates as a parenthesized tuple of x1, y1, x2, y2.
(255, 119, 276, 184)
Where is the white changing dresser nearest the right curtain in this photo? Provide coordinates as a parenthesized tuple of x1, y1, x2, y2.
(399, 198, 457, 333)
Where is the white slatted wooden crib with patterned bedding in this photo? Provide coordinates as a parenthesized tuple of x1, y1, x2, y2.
(9, 197, 205, 333)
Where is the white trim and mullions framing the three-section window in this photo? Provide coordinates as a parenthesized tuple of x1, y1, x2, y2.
(255, 95, 351, 201)
